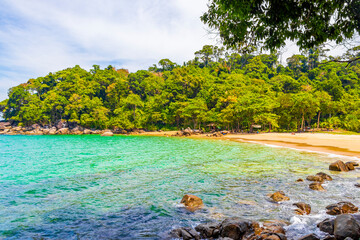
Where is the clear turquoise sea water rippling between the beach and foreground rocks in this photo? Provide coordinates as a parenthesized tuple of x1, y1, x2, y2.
(0, 135, 360, 239)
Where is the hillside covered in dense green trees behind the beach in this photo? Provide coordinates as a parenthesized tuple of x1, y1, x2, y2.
(0, 45, 360, 131)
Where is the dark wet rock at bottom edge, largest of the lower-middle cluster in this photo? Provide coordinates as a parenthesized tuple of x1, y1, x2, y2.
(220, 218, 252, 239)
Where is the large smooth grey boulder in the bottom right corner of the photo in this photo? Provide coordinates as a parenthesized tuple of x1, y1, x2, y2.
(334, 214, 360, 240)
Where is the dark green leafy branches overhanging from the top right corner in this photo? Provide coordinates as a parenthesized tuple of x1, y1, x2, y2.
(201, 0, 360, 50)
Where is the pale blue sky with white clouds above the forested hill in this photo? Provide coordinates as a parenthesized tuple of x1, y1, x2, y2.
(0, 0, 216, 100)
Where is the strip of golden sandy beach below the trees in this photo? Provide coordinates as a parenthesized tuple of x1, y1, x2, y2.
(139, 131, 360, 159)
